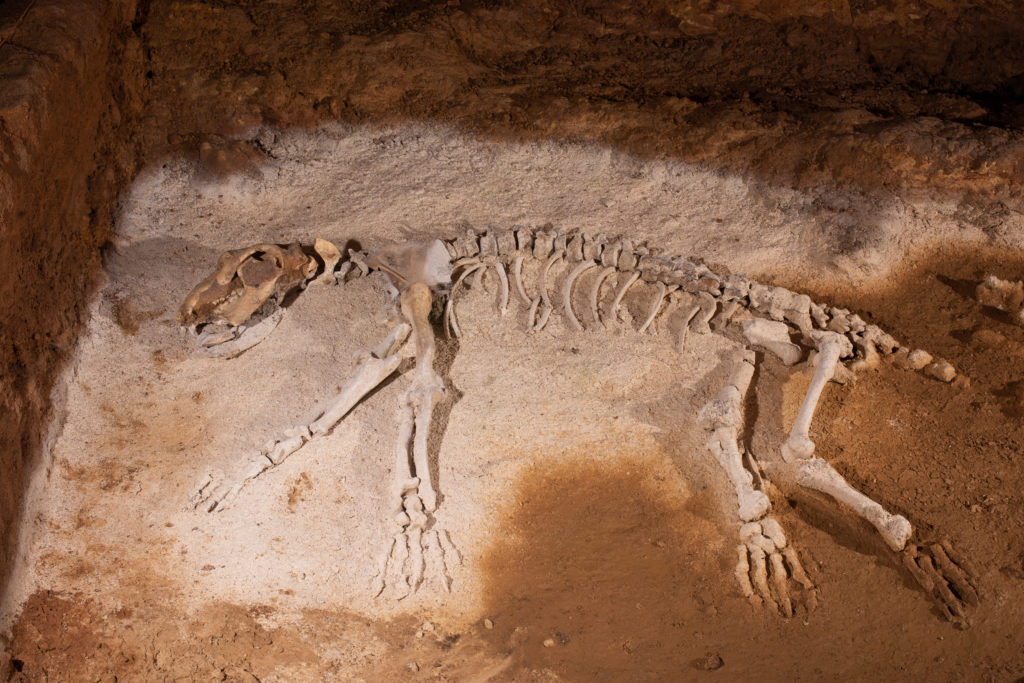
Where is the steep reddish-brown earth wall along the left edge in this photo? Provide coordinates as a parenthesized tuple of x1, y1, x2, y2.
(0, 0, 141, 587)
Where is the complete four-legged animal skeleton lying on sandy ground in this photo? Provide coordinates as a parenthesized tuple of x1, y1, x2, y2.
(179, 228, 978, 623)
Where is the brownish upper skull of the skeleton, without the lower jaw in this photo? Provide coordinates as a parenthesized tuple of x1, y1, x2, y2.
(178, 243, 317, 329)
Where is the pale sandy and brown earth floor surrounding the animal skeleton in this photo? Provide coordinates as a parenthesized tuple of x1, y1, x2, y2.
(11, 124, 1024, 681)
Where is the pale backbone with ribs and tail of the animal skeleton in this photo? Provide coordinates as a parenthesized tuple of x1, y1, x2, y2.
(350, 225, 951, 381)
